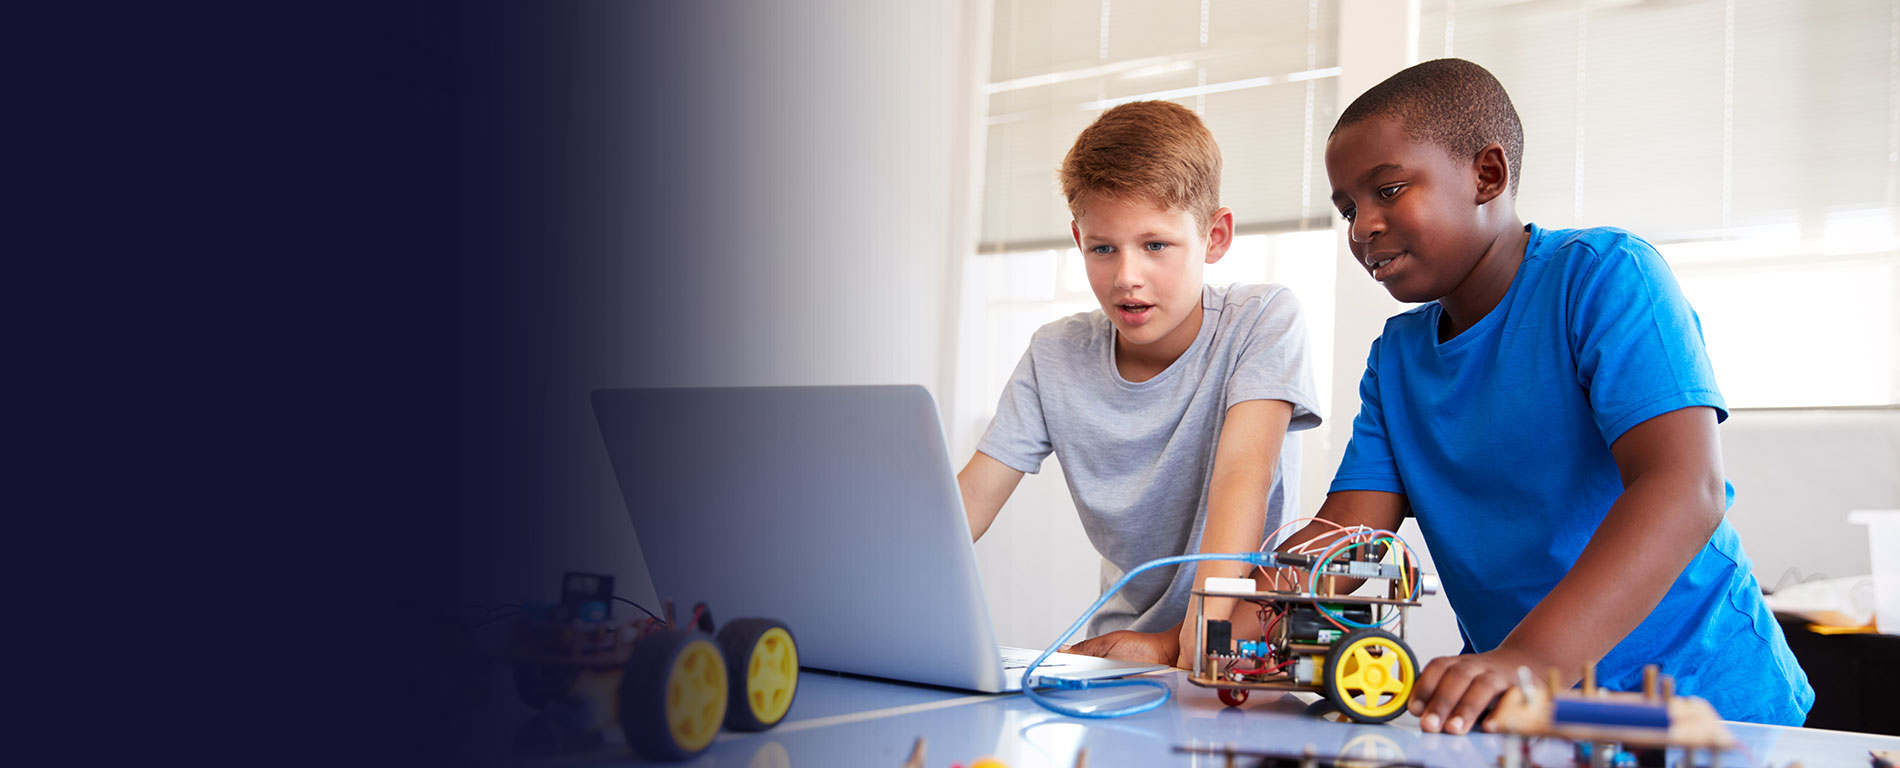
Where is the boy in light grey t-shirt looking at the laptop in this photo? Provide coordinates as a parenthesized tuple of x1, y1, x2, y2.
(958, 101, 1319, 667)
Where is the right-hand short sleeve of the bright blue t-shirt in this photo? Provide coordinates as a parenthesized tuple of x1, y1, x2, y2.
(1568, 238, 1729, 443)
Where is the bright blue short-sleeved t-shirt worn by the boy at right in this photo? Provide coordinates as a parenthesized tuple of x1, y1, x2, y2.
(1332, 224, 1815, 726)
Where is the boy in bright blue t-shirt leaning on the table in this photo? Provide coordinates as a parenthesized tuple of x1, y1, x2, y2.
(1283, 59, 1815, 734)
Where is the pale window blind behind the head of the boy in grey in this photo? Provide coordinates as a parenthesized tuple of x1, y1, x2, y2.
(982, 0, 1338, 253)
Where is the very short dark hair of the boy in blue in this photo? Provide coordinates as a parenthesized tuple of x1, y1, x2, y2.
(1332, 59, 1524, 196)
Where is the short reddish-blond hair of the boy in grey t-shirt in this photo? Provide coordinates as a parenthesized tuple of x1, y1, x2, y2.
(1062, 101, 1220, 230)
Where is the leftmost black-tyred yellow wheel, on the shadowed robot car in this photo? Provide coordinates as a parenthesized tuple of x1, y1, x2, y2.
(619, 631, 728, 760)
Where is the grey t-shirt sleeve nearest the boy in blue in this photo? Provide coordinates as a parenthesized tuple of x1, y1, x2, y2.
(1227, 289, 1319, 432)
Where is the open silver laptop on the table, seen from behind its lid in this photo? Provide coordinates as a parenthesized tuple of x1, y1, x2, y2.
(593, 386, 1163, 692)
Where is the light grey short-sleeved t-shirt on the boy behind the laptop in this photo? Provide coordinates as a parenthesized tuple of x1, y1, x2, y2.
(977, 285, 1319, 635)
